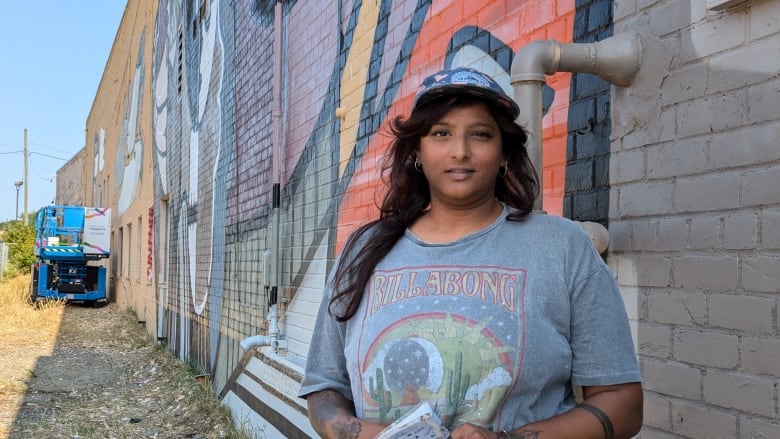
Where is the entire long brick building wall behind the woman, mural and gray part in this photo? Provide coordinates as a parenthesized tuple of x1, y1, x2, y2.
(64, 0, 780, 438)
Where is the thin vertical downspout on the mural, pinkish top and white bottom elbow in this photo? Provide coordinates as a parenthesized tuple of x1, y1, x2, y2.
(239, 0, 287, 354)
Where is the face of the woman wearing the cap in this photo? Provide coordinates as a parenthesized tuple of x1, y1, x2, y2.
(417, 104, 504, 209)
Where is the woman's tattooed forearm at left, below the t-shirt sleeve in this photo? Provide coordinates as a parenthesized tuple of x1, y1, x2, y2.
(306, 390, 385, 439)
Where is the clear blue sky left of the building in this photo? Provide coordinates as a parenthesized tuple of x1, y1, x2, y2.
(0, 0, 126, 222)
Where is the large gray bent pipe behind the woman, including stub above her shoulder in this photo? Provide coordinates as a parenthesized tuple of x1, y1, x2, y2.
(510, 33, 642, 253)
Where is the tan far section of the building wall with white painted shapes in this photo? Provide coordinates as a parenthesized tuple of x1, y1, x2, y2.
(84, 1, 157, 331)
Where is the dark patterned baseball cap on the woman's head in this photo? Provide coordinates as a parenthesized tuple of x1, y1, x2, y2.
(412, 67, 520, 119)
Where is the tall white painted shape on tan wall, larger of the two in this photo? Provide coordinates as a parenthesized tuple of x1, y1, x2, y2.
(117, 33, 145, 215)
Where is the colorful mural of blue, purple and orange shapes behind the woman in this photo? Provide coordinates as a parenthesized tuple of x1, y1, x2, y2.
(151, 0, 610, 437)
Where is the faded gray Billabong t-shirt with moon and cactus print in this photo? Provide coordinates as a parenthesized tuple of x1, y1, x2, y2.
(299, 209, 641, 430)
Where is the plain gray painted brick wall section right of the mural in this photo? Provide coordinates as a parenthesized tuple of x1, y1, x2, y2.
(609, 0, 780, 438)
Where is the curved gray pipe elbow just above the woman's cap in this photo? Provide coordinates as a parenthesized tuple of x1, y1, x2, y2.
(511, 40, 561, 85)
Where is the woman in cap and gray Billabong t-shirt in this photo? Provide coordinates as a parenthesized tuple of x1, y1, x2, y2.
(300, 68, 642, 439)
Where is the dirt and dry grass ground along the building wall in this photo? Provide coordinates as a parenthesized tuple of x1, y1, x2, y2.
(0, 304, 245, 439)
